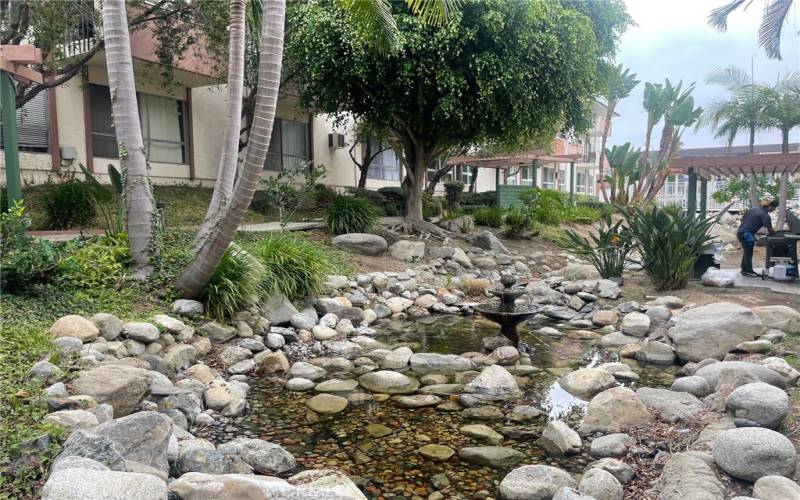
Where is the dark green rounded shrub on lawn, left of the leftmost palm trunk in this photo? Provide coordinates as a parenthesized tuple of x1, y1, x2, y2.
(44, 179, 96, 229)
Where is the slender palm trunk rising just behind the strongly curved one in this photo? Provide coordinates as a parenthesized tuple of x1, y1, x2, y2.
(200, 0, 246, 221)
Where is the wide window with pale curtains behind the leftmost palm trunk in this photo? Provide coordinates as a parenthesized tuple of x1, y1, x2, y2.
(89, 85, 188, 163)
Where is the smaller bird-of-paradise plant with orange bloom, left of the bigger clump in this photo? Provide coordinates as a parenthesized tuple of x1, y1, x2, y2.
(566, 218, 633, 278)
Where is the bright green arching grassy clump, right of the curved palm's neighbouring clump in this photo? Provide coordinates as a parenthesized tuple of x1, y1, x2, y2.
(246, 232, 343, 299)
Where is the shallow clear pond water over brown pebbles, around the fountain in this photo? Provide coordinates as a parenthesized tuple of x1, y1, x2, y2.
(209, 316, 671, 499)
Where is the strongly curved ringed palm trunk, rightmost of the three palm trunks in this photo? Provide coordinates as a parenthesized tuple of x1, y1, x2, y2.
(175, 0, 286, 297)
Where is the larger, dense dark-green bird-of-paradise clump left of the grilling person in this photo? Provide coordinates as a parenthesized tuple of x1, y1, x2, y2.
(620, 206, 726, 290)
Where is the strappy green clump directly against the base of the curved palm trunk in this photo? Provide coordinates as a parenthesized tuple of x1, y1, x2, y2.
(199, 243, 266, 319)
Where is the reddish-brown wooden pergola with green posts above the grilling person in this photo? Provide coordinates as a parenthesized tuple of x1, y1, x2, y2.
(670, 153, 800, 214)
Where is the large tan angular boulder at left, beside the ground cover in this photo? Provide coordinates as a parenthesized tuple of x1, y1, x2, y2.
(72, 365, 152, 417)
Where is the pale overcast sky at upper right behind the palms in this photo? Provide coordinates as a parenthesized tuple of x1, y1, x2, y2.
(609, 0, 800, 148)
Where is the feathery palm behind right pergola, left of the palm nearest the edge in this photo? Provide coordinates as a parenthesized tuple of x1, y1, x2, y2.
(702, 66, 765, 207)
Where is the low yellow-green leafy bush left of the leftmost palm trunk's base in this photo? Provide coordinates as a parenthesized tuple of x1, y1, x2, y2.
(58, 233, 130, 288)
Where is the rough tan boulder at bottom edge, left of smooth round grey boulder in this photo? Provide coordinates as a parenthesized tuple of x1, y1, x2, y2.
(657, 452, 725, 500)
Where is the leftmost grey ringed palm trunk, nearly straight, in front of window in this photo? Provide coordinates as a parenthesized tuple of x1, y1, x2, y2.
(103, 0, 153, 271)
